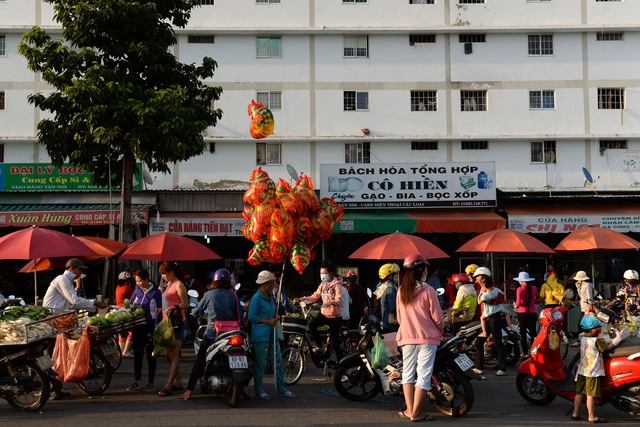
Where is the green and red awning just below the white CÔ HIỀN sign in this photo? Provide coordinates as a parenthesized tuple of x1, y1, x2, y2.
(333, 211, 506, 234)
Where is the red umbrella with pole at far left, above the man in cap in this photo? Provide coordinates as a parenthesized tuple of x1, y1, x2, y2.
(0, 226, 97, 302)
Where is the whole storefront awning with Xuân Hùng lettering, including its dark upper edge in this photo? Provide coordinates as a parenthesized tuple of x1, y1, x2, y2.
(0, 204, 153, 227)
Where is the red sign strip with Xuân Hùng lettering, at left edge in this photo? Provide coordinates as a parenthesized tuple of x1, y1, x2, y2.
(0, 209, 149, 227)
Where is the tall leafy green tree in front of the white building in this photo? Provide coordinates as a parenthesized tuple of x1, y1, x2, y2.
(19, 0, 222, 242)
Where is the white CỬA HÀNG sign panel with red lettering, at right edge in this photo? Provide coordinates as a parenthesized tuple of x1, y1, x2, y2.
(509, 214, 640, 233)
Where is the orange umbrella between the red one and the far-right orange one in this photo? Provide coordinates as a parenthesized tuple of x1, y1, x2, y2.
(456, 228, 555, 254)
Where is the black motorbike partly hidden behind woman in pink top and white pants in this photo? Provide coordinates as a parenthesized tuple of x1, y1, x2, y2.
(333, 315, 482, 417)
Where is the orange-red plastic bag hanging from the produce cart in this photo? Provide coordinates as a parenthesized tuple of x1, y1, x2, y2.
(51, 329, 91, 382)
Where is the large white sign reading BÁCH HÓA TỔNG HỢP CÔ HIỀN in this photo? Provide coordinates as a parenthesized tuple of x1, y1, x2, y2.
(320, 162, 496, 209)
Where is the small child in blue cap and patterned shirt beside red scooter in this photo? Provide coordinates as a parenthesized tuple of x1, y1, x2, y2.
(571, 316, 629, 424)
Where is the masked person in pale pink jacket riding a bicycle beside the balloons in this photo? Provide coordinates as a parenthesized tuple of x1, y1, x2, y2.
(300, 261, 343, 360)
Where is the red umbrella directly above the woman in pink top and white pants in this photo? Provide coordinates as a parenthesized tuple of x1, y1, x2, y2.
(349, 232, 449, 260)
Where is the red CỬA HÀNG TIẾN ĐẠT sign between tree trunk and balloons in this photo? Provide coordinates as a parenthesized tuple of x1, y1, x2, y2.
(149, 216, 244, 237)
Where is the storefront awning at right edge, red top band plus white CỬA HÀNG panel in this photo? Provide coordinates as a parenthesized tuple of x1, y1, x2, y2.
(505, 205, 640, 233)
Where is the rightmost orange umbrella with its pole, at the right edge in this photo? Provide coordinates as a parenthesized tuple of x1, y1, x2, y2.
(556, 225, 640, 283)
